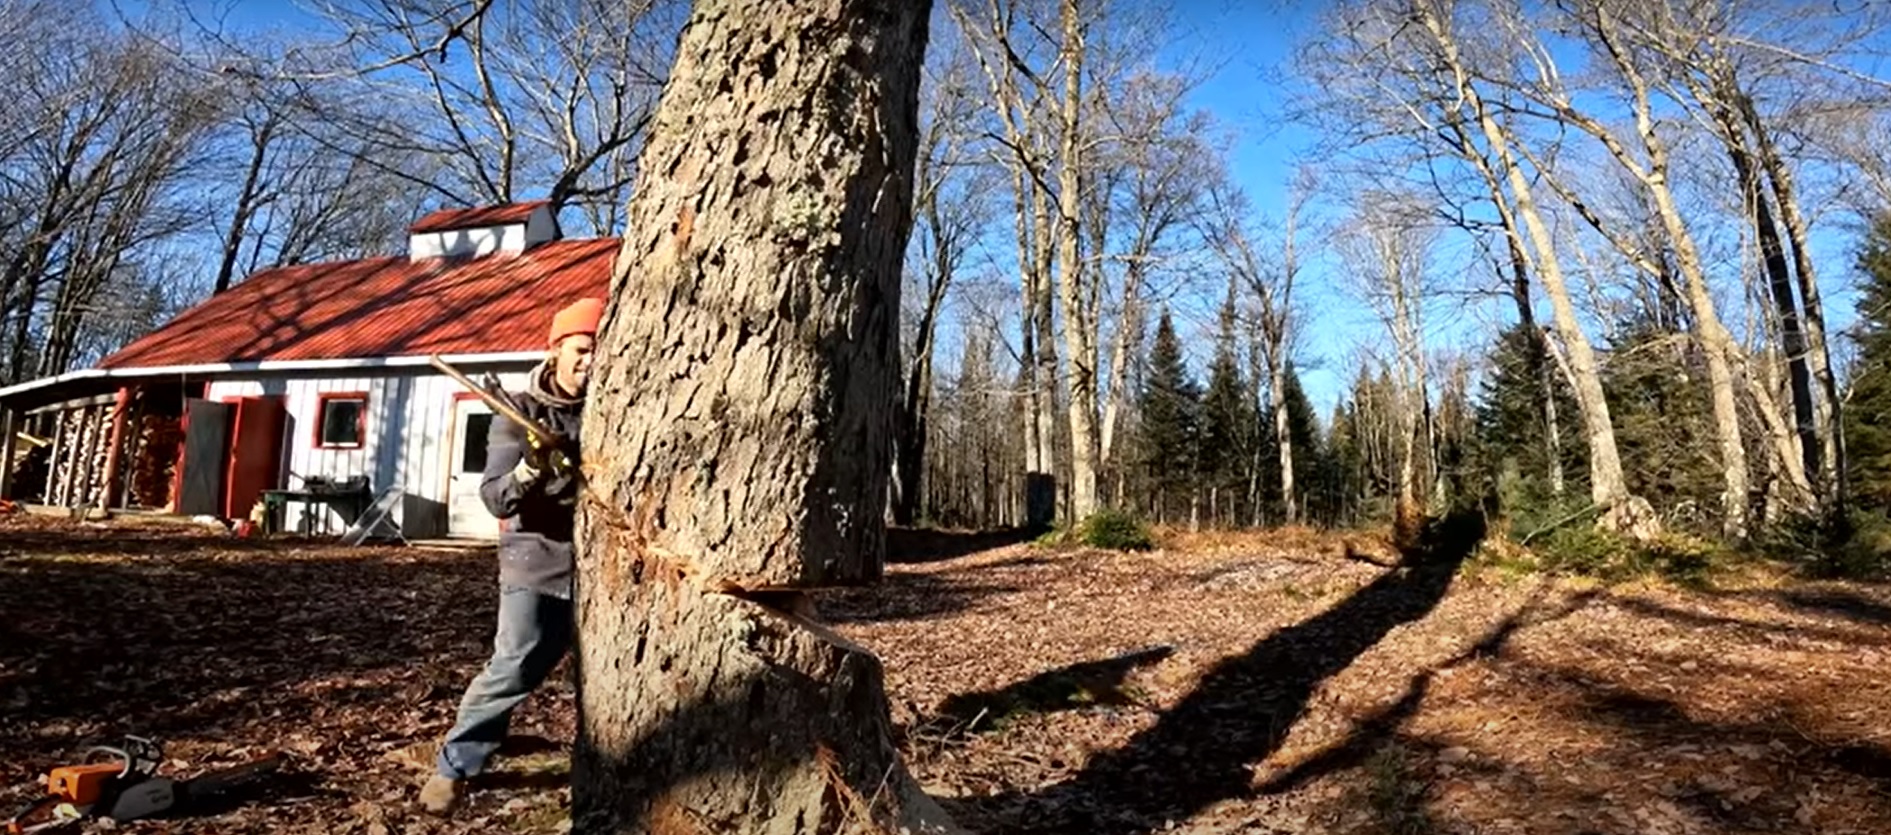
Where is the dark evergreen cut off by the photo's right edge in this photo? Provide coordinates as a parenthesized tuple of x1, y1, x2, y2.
(1844, 212, 1891, 514)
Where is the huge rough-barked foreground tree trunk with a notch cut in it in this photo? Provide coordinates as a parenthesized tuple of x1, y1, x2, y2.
(573, 0, 951, 833)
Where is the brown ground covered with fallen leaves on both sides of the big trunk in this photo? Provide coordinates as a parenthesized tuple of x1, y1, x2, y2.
(0, 516, 1891, 835)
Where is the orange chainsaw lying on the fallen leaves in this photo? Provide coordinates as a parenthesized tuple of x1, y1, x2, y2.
(6, 737, 282, 835)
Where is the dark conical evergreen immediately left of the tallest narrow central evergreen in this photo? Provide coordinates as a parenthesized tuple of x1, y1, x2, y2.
(1138, 308, 1201, 520)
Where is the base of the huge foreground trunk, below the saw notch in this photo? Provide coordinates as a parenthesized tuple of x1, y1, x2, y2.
(571, 580, 959, 835)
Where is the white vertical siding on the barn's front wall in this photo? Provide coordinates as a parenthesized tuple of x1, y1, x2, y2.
(206, 370, 526, 537)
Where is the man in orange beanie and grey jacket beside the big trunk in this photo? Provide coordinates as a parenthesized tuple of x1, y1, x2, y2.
(420, 298, 603, 814)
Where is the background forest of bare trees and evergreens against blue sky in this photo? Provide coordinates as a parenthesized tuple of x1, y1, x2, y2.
(11, 0, 1891, 570)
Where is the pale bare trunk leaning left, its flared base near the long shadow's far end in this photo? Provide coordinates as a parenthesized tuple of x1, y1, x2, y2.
(1416, 4, 1658, 538)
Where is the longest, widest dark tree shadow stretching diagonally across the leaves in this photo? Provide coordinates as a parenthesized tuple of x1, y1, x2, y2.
(972, 512, 1486, 833)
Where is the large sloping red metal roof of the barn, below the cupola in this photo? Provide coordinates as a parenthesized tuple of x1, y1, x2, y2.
(100, 238, 618, 368)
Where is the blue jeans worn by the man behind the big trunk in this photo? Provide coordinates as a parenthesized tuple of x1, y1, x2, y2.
(435, 586, 573, 780)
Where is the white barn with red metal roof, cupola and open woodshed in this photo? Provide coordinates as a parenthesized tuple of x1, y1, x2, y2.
(0, 202, 618, 538)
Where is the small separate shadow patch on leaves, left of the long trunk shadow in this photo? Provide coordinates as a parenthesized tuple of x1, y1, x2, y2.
(934, 646, 1174, 733)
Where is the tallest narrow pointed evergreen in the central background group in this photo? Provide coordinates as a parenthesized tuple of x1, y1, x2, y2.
(1201, 285, 1261, 521)
